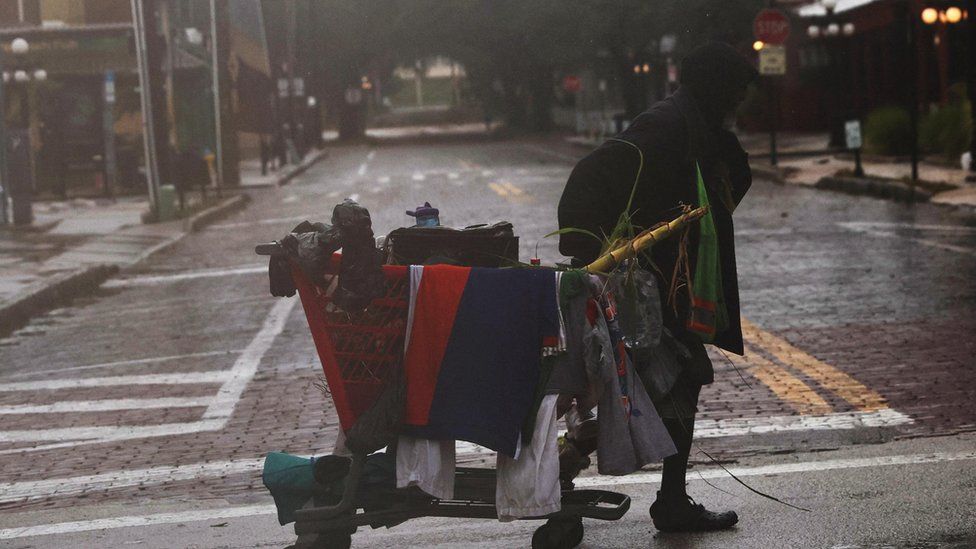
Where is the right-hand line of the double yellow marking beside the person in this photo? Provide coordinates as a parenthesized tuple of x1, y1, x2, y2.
(742, 318, 888, 412)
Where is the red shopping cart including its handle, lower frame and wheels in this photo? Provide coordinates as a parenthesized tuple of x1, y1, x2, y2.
(255, 243, 630, 549)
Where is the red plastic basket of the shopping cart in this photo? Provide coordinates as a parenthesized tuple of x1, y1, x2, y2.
(292, 254, 409, 431)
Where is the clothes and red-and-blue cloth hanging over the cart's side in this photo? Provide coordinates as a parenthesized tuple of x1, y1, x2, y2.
(384, 265, 675, 520)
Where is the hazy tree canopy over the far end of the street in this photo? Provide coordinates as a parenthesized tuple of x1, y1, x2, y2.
(310, 0, 764, 136)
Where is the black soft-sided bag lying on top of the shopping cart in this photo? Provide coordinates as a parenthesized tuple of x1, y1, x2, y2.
(384, 221, 518, 267)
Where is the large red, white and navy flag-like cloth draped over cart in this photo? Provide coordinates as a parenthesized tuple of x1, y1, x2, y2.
(404, 265, 559, 457)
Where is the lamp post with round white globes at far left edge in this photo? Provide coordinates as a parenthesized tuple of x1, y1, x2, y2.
(0, 37, 47, 225)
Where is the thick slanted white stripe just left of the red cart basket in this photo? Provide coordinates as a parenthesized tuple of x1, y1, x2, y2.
(203, 298, 298, 420)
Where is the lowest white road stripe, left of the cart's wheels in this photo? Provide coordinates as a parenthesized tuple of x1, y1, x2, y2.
(0, 504, 277, 539)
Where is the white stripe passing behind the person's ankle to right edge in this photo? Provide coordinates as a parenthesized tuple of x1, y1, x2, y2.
(573, 452, 976, 488)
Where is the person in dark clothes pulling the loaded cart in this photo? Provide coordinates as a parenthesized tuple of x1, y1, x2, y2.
(559, 42, 757, 531)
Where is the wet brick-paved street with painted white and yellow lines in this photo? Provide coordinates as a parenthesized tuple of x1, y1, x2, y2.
(0, 134, 976, 547)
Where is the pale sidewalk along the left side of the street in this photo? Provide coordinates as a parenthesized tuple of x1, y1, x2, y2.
(0, 151, 325, 336)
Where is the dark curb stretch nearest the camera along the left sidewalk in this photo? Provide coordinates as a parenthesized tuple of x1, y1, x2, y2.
(0, 265, 119, 336)
